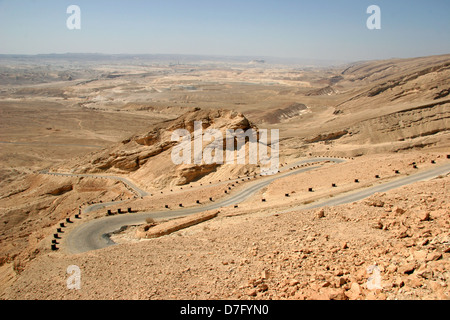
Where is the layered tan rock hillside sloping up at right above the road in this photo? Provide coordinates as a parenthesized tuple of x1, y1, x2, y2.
(299, 55, 450, 156)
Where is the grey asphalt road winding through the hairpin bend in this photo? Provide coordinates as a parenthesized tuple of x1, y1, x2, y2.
(60, 158, 450, 254)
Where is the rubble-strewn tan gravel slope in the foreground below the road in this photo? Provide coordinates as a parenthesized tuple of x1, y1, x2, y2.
(1, 165, 450, 300)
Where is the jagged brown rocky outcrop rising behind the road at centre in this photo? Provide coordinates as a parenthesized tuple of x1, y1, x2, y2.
(58, 108, 266, 189)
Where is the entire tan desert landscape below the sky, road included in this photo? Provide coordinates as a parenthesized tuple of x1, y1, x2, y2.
(0, 50, 450, 300)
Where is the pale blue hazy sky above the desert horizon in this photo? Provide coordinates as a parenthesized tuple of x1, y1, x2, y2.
(0, 0, 450, 61)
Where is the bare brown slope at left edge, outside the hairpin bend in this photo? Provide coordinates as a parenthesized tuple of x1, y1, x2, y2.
(0, 174, 132, 271)
